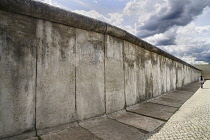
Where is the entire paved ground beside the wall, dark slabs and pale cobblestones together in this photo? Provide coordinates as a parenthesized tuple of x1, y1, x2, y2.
(23, 81, 203, 140)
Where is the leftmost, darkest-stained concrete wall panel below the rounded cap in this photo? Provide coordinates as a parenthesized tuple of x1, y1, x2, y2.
(0, 10, 36, 139)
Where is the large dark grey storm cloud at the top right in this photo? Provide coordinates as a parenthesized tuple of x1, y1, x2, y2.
(137, 0, 210, 38)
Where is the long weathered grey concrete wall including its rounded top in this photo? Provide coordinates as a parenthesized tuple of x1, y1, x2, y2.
(0, 0, 200, 139)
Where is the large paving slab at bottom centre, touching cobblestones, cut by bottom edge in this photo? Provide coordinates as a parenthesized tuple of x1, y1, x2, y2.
(80, 118, 144, 140)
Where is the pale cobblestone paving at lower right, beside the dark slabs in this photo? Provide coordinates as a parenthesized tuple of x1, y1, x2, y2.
(149, 80, 210, 140)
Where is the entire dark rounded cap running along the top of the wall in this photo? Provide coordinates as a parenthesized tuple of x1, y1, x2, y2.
(0, 0, 201, 71)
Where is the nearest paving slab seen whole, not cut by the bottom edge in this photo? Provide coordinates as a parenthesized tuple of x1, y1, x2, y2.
(109, 112, 165, 132)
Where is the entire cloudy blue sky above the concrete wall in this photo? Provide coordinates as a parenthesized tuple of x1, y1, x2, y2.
(36, 0, 210, 65)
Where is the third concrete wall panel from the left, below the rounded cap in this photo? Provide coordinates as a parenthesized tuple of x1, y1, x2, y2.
(76, 29, 104, 120)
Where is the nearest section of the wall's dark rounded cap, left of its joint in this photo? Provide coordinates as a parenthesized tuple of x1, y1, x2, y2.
(0, 0, 106, 33)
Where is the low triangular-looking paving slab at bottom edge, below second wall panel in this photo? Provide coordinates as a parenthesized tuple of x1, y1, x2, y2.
(41, 126, 101, 140)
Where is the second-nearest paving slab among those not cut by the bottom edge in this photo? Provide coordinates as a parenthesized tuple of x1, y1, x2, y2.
(129, 102, 177, 120)
